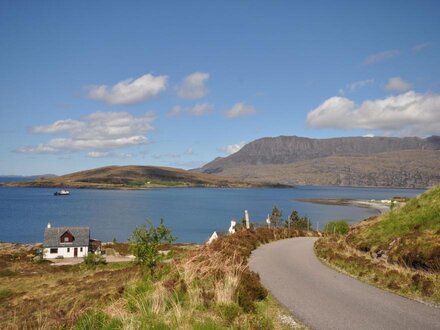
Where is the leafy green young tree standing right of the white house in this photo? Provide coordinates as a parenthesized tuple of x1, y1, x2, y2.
(129, 219, 176, 274)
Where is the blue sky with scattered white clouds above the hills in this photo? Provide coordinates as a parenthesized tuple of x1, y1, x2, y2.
(0, 1, 440, 175)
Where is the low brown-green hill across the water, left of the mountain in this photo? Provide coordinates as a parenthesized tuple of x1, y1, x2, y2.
(7, 166, 282, 189)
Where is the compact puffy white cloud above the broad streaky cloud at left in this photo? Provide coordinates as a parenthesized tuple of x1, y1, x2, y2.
(87, 73, 168, 105)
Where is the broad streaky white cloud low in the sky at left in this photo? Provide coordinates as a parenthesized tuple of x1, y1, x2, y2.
(17, 112, 154, 157)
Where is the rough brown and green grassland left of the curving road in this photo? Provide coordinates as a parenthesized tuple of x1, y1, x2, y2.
(0, 228, 312, 329)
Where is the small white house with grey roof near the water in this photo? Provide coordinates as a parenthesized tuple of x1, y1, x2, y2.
(43, 223, 92, 259)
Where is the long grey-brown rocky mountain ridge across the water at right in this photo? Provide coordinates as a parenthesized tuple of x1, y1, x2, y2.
(195, 136, 440, 187)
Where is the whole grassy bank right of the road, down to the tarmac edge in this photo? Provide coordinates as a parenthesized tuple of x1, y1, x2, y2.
(315, 187, 440, 307)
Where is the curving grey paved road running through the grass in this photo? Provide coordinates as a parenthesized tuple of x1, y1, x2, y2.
(249, 237, 440, 330)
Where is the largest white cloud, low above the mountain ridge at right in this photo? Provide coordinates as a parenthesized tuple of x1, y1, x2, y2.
(307, 91, 440, 136)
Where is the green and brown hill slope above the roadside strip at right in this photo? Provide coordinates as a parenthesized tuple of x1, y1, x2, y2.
(347, 186, 440, 271)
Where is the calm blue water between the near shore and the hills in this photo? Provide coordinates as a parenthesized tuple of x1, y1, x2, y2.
(0, 186, 423, 243)
